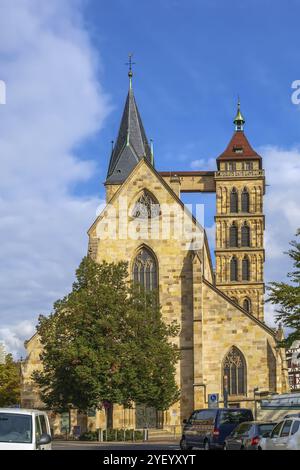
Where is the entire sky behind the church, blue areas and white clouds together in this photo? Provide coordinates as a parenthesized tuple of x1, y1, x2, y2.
(0, 0, 300, 355)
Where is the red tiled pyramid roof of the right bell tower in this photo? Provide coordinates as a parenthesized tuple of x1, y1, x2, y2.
(217, 131, 261, 167)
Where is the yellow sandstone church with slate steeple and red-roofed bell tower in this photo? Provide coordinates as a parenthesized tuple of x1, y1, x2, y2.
(22, 74, 289, 432)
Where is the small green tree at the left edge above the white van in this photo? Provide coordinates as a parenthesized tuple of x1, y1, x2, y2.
(0, 354, 21, 408)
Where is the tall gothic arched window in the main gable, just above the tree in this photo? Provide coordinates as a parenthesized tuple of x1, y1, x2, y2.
(132, 247, 158, 291)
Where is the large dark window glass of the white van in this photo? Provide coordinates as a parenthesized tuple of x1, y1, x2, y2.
(0, 413, 32, 444)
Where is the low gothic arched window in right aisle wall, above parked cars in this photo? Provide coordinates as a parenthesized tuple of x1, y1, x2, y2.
(223, 346, 247, 395)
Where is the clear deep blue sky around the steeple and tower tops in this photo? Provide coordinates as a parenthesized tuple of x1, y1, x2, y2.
(78, 0, 300, 190)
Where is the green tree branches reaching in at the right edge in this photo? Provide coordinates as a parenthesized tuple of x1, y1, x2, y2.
(268, 229, 300, 347)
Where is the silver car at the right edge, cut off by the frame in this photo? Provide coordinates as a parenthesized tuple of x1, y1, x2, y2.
(261, 417, 300, 450)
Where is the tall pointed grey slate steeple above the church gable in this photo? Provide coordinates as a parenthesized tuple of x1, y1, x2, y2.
(106, 61, 152, 184)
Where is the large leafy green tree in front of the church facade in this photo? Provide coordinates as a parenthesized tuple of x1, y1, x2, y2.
(33, 257, 179, 411)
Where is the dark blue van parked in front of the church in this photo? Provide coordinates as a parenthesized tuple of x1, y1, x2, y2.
(180, 408, 253, 450)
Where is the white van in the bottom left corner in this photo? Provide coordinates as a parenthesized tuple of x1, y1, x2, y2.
(0, 408, 52, 450)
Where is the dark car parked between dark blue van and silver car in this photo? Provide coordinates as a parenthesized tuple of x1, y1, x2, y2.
(224, 421, 276, 450)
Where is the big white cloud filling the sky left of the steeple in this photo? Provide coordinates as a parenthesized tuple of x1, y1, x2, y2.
(0, 0, 110, 354)
